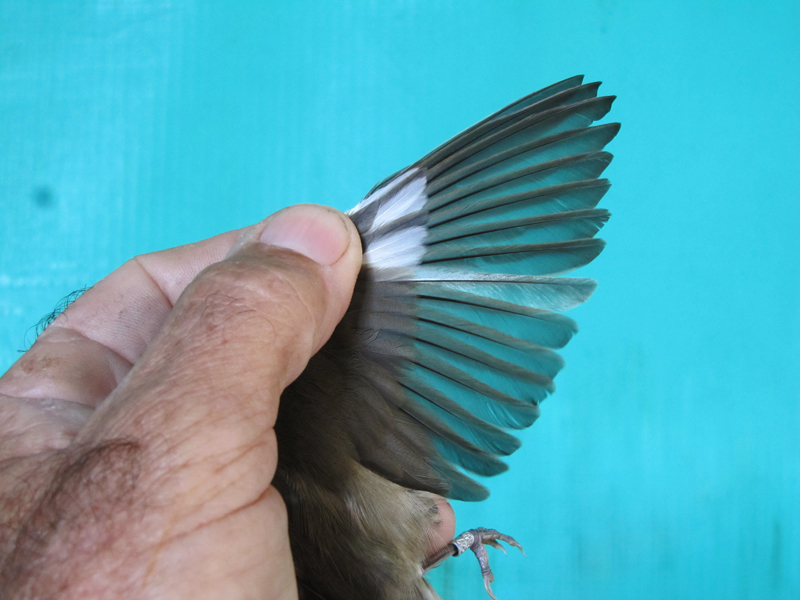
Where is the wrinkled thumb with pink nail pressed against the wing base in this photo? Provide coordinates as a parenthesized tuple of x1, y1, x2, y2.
(83, 205, 361, 454)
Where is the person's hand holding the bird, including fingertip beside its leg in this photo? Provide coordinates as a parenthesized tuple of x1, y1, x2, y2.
(0, 205, 454, 600)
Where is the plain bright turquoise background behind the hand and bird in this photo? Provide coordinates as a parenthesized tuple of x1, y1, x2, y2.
(0, 0, 800, 600)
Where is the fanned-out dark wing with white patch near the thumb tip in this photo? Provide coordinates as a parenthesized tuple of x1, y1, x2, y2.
(334, 77, 619, 500)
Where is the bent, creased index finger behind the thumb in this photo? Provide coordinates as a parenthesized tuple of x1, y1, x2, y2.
(0, 231, 241, 407)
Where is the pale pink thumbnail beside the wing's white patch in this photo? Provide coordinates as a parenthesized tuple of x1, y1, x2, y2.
(258, 204, 350, 265)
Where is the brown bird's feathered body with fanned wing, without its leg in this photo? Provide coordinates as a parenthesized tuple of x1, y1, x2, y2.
(275, 77, 619, 600)
